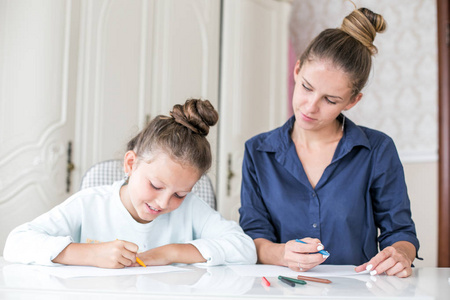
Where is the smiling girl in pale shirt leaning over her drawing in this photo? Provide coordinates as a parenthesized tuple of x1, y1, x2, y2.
(4, 99, 256, 268)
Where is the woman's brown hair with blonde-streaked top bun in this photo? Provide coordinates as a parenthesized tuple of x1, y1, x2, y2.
(300, 8, 387, 97)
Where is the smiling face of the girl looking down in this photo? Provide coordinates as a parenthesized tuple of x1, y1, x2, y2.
(120, 151, 200, 223)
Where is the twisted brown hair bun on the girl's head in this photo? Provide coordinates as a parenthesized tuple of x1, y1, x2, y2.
(170, 99, 219, 136)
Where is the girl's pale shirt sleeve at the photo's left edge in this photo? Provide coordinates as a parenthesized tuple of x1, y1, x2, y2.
(3, 198, 81, 266)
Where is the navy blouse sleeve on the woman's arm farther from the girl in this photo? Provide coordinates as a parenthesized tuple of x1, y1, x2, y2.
(370, 138, 419, 256)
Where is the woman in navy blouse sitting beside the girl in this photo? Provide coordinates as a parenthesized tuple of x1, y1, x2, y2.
(240, 8, 419, 277)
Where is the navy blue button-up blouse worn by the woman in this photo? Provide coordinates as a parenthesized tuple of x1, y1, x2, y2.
(239, 117, 419, 265)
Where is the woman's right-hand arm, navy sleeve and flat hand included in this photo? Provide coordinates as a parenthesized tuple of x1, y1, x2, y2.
(356, 139, 419, 277)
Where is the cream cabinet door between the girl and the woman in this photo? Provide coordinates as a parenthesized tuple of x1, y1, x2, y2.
(218, 0, 290, 221)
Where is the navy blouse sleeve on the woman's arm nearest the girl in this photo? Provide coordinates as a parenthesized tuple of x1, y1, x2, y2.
(239, 142, 279, 243)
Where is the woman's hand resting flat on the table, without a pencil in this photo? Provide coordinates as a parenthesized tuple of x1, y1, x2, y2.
(355, 241, 416, 278)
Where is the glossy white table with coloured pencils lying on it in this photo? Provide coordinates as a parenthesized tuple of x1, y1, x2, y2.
(0, 258, 450, 300)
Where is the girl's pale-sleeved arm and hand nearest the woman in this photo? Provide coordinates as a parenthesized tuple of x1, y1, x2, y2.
(152, 194, 256, 266)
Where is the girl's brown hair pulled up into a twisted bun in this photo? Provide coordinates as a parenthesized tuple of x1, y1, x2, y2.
(127, 99, 219, 174)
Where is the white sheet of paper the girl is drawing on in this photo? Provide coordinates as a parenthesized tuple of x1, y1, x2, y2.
(5, 264, 189, 278)
